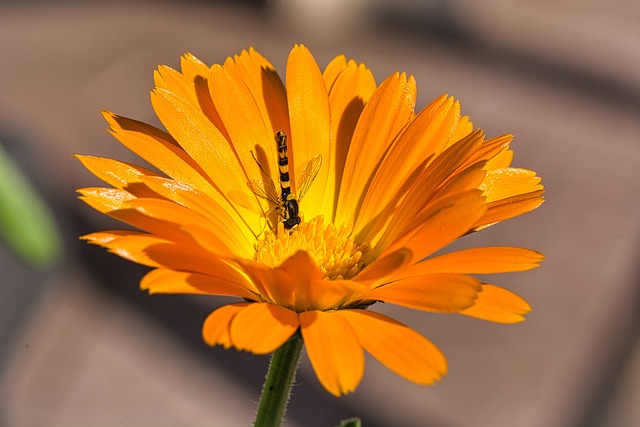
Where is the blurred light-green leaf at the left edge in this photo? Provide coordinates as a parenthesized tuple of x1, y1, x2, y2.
(0, 145, 62, 267)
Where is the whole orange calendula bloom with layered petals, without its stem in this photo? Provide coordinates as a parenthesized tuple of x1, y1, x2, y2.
(78, 45, 543, 396)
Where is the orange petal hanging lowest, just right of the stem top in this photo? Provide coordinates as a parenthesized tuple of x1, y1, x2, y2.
(300, 311, 364, 396)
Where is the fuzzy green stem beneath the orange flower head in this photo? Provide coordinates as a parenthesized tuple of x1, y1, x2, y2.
(254, 332, 303, 427)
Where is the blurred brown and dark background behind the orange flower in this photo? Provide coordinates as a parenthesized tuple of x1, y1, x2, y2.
(0, 0, 640, 427)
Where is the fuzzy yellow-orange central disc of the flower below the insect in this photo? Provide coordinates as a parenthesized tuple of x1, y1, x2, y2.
(256, 216, 370, 280)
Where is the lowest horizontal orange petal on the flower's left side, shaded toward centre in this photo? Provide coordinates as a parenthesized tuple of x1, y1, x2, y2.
(140, 268, 256, 299)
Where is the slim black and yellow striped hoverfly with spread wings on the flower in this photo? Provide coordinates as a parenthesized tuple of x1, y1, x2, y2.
(247, 130, 322, 230)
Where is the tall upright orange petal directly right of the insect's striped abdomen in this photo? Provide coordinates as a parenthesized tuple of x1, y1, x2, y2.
(286, 45, 335, 218)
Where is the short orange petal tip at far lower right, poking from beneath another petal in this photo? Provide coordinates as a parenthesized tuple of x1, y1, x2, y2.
(460, 284, 531, 323)
